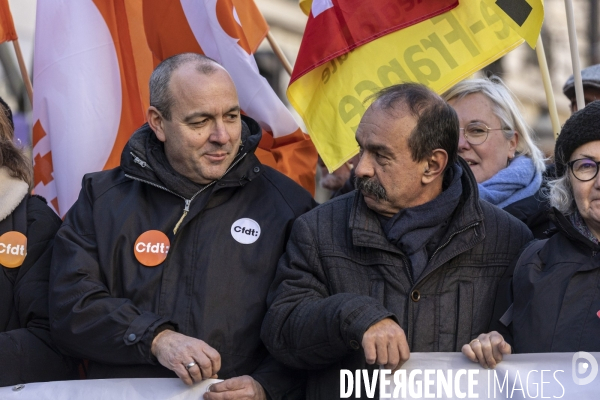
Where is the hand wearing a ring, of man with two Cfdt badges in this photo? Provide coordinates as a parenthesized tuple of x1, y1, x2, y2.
(151, 330, 221, 385)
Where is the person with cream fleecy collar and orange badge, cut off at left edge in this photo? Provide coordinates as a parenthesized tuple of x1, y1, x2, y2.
(0, 99, 77, 386)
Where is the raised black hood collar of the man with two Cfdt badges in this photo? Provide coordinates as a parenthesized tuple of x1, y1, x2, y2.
(121, 115, 262, 199)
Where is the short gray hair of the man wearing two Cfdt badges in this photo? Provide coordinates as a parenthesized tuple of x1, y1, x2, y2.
(150, 53, 219, 121)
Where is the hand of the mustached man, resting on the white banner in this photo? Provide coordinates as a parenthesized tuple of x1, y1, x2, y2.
(362, 318, 410, 370)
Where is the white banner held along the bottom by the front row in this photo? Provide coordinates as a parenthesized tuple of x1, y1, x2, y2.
(0, 352, 600, 400)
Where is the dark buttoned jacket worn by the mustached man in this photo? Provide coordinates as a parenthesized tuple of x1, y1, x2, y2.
(261, 161, 531, 400)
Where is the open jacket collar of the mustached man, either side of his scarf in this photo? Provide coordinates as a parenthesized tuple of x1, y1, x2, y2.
(349, 157, 485, 277)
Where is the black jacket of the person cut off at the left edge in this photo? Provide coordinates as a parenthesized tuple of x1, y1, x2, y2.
(0, 195, 77, 386)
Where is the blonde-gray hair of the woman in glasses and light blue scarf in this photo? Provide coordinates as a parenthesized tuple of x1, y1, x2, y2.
(442, 75, 546, 172)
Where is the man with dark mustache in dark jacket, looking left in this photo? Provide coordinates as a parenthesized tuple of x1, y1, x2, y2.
(261, 83, 532, 399)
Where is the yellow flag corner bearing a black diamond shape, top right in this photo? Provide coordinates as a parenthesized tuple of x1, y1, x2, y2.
(484, 0, 544, 49)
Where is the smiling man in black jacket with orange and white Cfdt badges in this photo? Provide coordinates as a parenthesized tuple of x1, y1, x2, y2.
(50, 53, 314, 399)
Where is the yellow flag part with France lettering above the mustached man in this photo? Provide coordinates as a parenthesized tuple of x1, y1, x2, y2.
(287, 0, 523, 170)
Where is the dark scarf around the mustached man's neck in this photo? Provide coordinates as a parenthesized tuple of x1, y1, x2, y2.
(382, 164, 463, 280)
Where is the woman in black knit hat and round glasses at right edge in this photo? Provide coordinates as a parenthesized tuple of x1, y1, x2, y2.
(462, 101, 600, 368)
